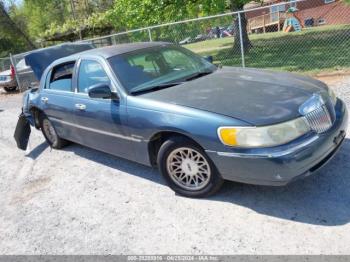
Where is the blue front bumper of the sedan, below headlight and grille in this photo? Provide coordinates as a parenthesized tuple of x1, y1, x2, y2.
(206, 100, 348, 186)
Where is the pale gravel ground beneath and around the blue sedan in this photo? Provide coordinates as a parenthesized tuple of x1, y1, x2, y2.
(0, 77, 350, 255)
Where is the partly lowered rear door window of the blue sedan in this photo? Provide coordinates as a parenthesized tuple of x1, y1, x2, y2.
(46, 62, 75, 91)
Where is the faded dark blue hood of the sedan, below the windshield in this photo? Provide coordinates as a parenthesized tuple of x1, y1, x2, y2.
(142, 67, 327, 126)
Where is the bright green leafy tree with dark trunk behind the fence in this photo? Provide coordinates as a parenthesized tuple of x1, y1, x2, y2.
(110, 0, 262, 51)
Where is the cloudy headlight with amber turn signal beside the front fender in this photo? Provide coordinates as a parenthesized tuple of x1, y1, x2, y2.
(218, 117, 310, 148)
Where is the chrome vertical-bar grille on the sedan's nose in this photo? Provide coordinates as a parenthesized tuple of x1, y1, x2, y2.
(305, 105, 333, 133)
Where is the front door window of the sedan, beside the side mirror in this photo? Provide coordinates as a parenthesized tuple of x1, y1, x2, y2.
(78, 60, 110, 93)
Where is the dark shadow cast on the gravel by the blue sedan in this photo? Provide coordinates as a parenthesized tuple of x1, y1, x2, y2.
(27, 138, 350, 226)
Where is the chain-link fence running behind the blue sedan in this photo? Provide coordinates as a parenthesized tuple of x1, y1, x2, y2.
(0, 0, 350, 92)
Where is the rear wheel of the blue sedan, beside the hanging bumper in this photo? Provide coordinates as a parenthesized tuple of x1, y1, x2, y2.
(40, 114, 68, 149)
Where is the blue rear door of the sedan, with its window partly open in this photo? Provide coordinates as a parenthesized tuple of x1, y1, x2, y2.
(40, 61, 78, 141)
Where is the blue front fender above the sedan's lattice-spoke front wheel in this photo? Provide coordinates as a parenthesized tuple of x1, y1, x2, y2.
(125, 97, 249, 165)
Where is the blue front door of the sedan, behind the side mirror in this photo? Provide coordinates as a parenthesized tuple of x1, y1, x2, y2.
(74, 58, 135, 158)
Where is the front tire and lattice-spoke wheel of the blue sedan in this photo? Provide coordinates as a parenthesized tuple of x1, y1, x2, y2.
(157, 137, 224, 198)
